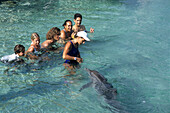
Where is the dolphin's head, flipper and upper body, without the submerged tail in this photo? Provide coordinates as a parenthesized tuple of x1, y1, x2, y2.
(79, 68, 117, 99)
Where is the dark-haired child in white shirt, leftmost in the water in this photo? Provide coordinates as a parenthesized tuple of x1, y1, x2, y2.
(1, 44, 25, 63)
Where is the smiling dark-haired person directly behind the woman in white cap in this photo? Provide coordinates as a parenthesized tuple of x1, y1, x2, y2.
(60, 20, 72, 41)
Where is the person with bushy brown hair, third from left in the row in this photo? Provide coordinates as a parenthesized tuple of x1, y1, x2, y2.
(41, 27, 64, 50)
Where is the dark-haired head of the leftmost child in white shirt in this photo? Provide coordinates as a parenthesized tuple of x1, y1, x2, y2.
(14, 44, 25, 56)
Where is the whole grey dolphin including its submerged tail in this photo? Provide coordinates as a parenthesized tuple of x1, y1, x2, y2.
(79, 68, 127, 113)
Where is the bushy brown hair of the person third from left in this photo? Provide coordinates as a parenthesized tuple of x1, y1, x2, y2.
(46, 27, 60, 40)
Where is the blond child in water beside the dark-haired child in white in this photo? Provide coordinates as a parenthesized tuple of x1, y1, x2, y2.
(26, 33, 41, 59)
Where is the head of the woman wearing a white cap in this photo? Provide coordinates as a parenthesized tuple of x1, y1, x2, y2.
(76, 31, 90, 45)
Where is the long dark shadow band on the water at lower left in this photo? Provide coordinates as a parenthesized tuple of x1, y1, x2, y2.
(0, 81, 68, 102)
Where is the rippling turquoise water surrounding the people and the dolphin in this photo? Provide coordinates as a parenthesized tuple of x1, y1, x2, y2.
(0, 0, 170, 113)
